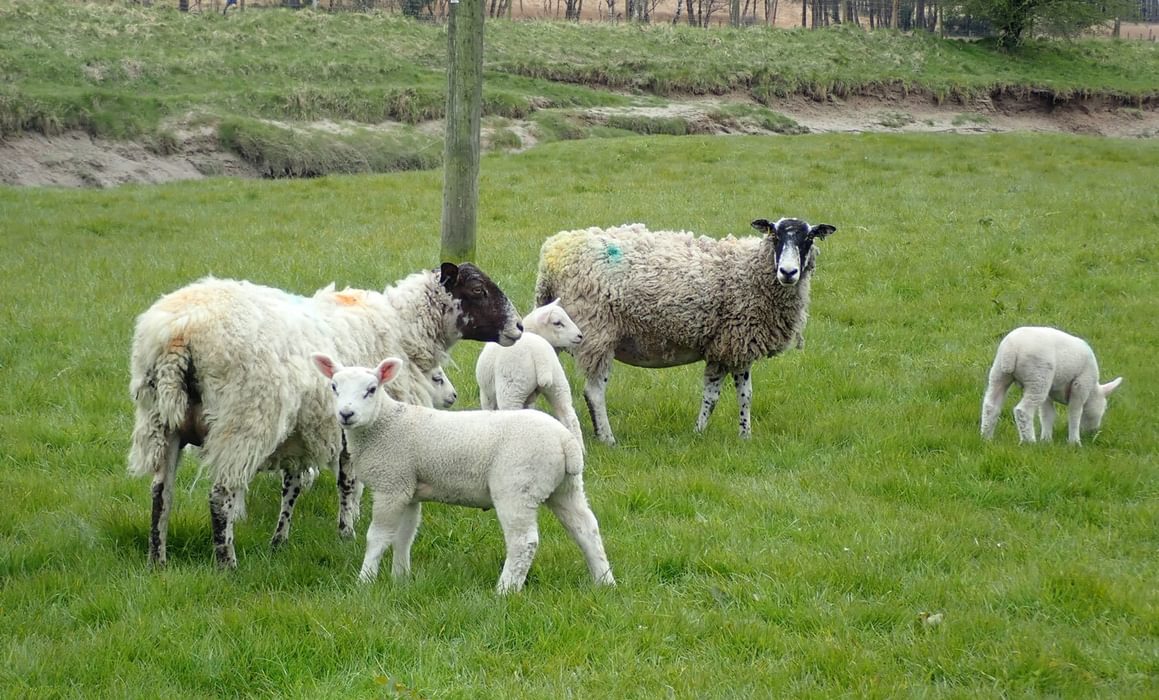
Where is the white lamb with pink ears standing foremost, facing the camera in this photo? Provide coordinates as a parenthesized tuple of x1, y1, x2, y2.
(313, 353, 615, 593)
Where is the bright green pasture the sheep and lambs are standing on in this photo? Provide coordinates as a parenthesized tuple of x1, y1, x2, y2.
(0, 133, 1159, 699)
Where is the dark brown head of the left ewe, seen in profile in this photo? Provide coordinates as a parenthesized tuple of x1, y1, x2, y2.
(439, 263, 523, 345)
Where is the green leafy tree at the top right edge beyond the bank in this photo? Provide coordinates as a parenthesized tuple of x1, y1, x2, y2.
(961, 0, 1139, 50)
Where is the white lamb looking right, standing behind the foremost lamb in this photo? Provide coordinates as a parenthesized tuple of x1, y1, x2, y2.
(475, 299, 583, 446)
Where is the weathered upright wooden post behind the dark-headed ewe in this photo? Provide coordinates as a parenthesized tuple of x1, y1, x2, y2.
(442, 0, 483, 262)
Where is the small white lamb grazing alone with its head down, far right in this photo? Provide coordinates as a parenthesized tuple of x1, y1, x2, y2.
(982, 326, 1123, 445)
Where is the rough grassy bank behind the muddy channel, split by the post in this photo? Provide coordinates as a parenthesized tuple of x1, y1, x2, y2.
(0, 0, 1159, 175)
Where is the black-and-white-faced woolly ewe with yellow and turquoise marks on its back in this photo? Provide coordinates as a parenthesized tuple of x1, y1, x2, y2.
(535, 219, 837, 445)
